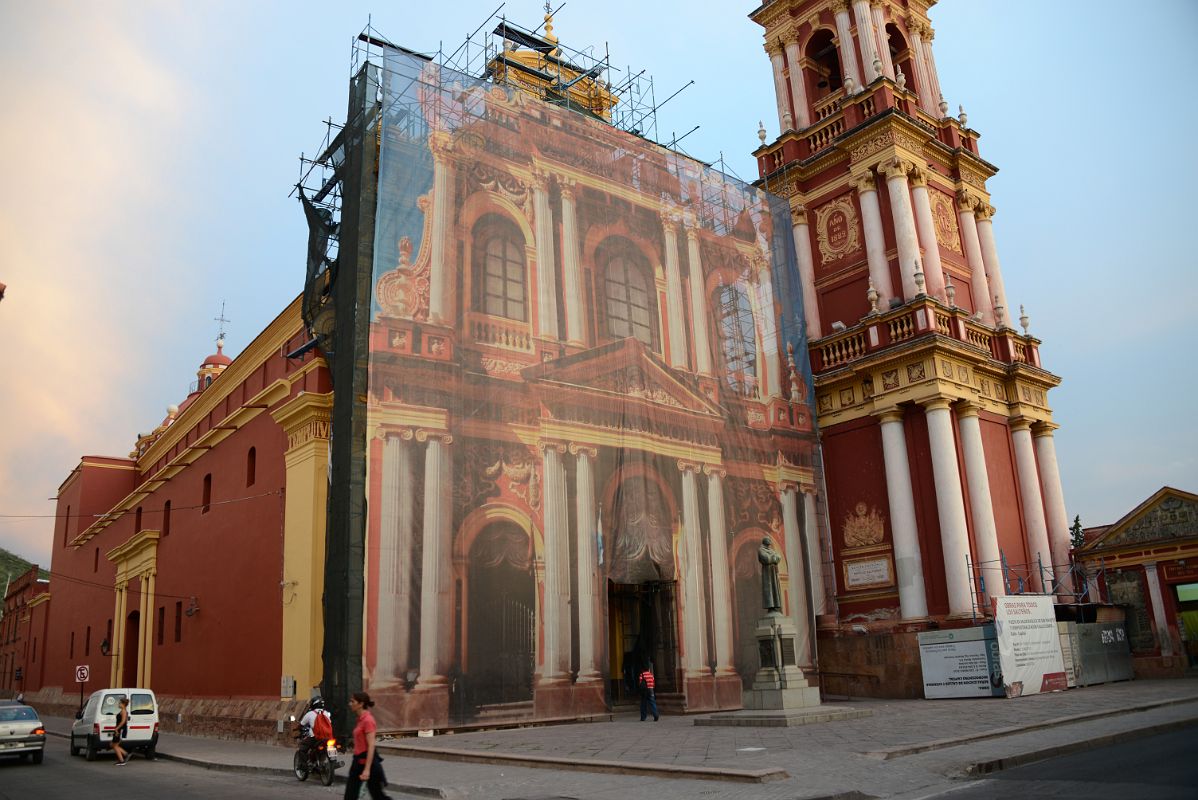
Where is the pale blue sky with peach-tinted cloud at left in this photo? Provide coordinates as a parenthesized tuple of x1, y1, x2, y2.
(0, 0, 1198, 565)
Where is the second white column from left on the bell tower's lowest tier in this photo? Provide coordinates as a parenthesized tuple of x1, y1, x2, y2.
(924, 398, 974, 616)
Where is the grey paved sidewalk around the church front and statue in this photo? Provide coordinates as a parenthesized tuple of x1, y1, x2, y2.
(44, 680, 1198, 800)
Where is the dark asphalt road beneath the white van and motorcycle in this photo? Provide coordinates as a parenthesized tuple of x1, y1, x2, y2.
(0, 737, 357, 800)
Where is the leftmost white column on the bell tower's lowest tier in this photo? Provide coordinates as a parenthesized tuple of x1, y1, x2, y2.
(878, 408, 927, 619)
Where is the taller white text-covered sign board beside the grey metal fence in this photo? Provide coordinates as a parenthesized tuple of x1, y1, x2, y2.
(991, 595, 1067, 697)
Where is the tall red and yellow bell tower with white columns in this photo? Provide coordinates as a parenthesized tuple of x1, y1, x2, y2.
(750, 0, 1075, 696)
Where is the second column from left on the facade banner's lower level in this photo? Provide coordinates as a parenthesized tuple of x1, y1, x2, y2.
(416, 430, 453, 690)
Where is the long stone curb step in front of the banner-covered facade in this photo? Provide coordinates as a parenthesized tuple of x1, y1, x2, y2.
(379, 745, 791, 783)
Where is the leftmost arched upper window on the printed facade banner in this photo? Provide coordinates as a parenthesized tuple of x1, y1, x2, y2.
(473, 214, 528, 322)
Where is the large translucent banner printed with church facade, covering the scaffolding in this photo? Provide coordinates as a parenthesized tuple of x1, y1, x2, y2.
(354, 51, 822, 728)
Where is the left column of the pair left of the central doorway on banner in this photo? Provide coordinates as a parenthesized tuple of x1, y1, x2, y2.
(538, 443, 570, 683)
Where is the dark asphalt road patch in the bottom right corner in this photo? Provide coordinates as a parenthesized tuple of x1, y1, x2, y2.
(938, 728, 1198, 800)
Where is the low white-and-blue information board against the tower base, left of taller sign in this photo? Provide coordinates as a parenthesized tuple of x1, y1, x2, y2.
(919, 625, 1004, 699)
